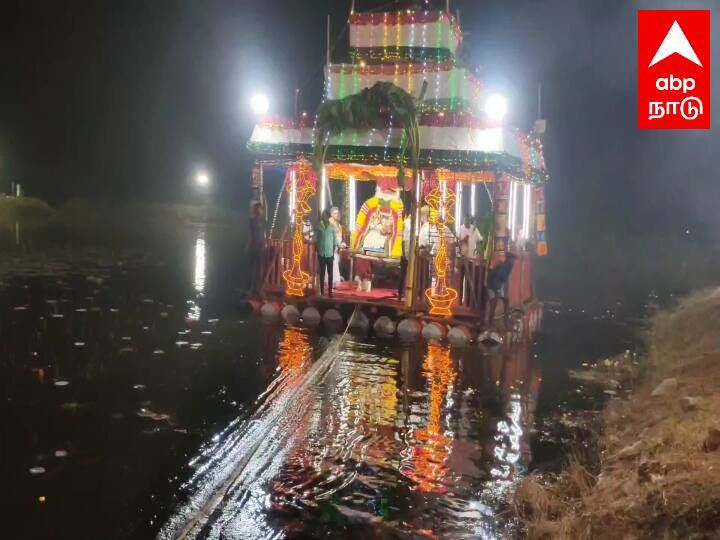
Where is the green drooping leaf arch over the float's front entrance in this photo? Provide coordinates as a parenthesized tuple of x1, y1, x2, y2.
(313, 81, 427, 187)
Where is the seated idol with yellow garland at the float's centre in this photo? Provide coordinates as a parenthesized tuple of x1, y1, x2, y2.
(352, 186, 403, 257)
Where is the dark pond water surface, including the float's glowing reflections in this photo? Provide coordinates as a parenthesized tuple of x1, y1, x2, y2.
(0, 229, 632, 539)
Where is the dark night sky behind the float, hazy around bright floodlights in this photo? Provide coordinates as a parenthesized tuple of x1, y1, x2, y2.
(0, 0, 720, 286)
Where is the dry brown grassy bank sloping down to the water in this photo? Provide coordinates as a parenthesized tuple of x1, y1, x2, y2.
(515, 289, 720, 540)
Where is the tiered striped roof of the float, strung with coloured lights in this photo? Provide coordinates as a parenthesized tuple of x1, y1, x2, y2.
(248, 9, 547, 183)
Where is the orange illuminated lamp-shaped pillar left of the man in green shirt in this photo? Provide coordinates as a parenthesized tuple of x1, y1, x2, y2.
(283, 160, 317, 296)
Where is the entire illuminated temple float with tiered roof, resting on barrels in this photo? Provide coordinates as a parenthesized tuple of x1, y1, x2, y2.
(248, 3, 548, 342)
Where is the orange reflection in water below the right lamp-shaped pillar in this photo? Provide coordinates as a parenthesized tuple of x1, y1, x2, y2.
(400, 343, 457, 493)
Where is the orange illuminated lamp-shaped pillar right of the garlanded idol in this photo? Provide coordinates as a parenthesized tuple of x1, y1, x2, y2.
(425, 180, 458, 317)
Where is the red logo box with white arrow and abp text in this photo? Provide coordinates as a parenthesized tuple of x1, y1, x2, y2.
(638, 10, 710, 129)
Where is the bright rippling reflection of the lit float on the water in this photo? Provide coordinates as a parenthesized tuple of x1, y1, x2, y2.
(161, 328, 537, 539)
